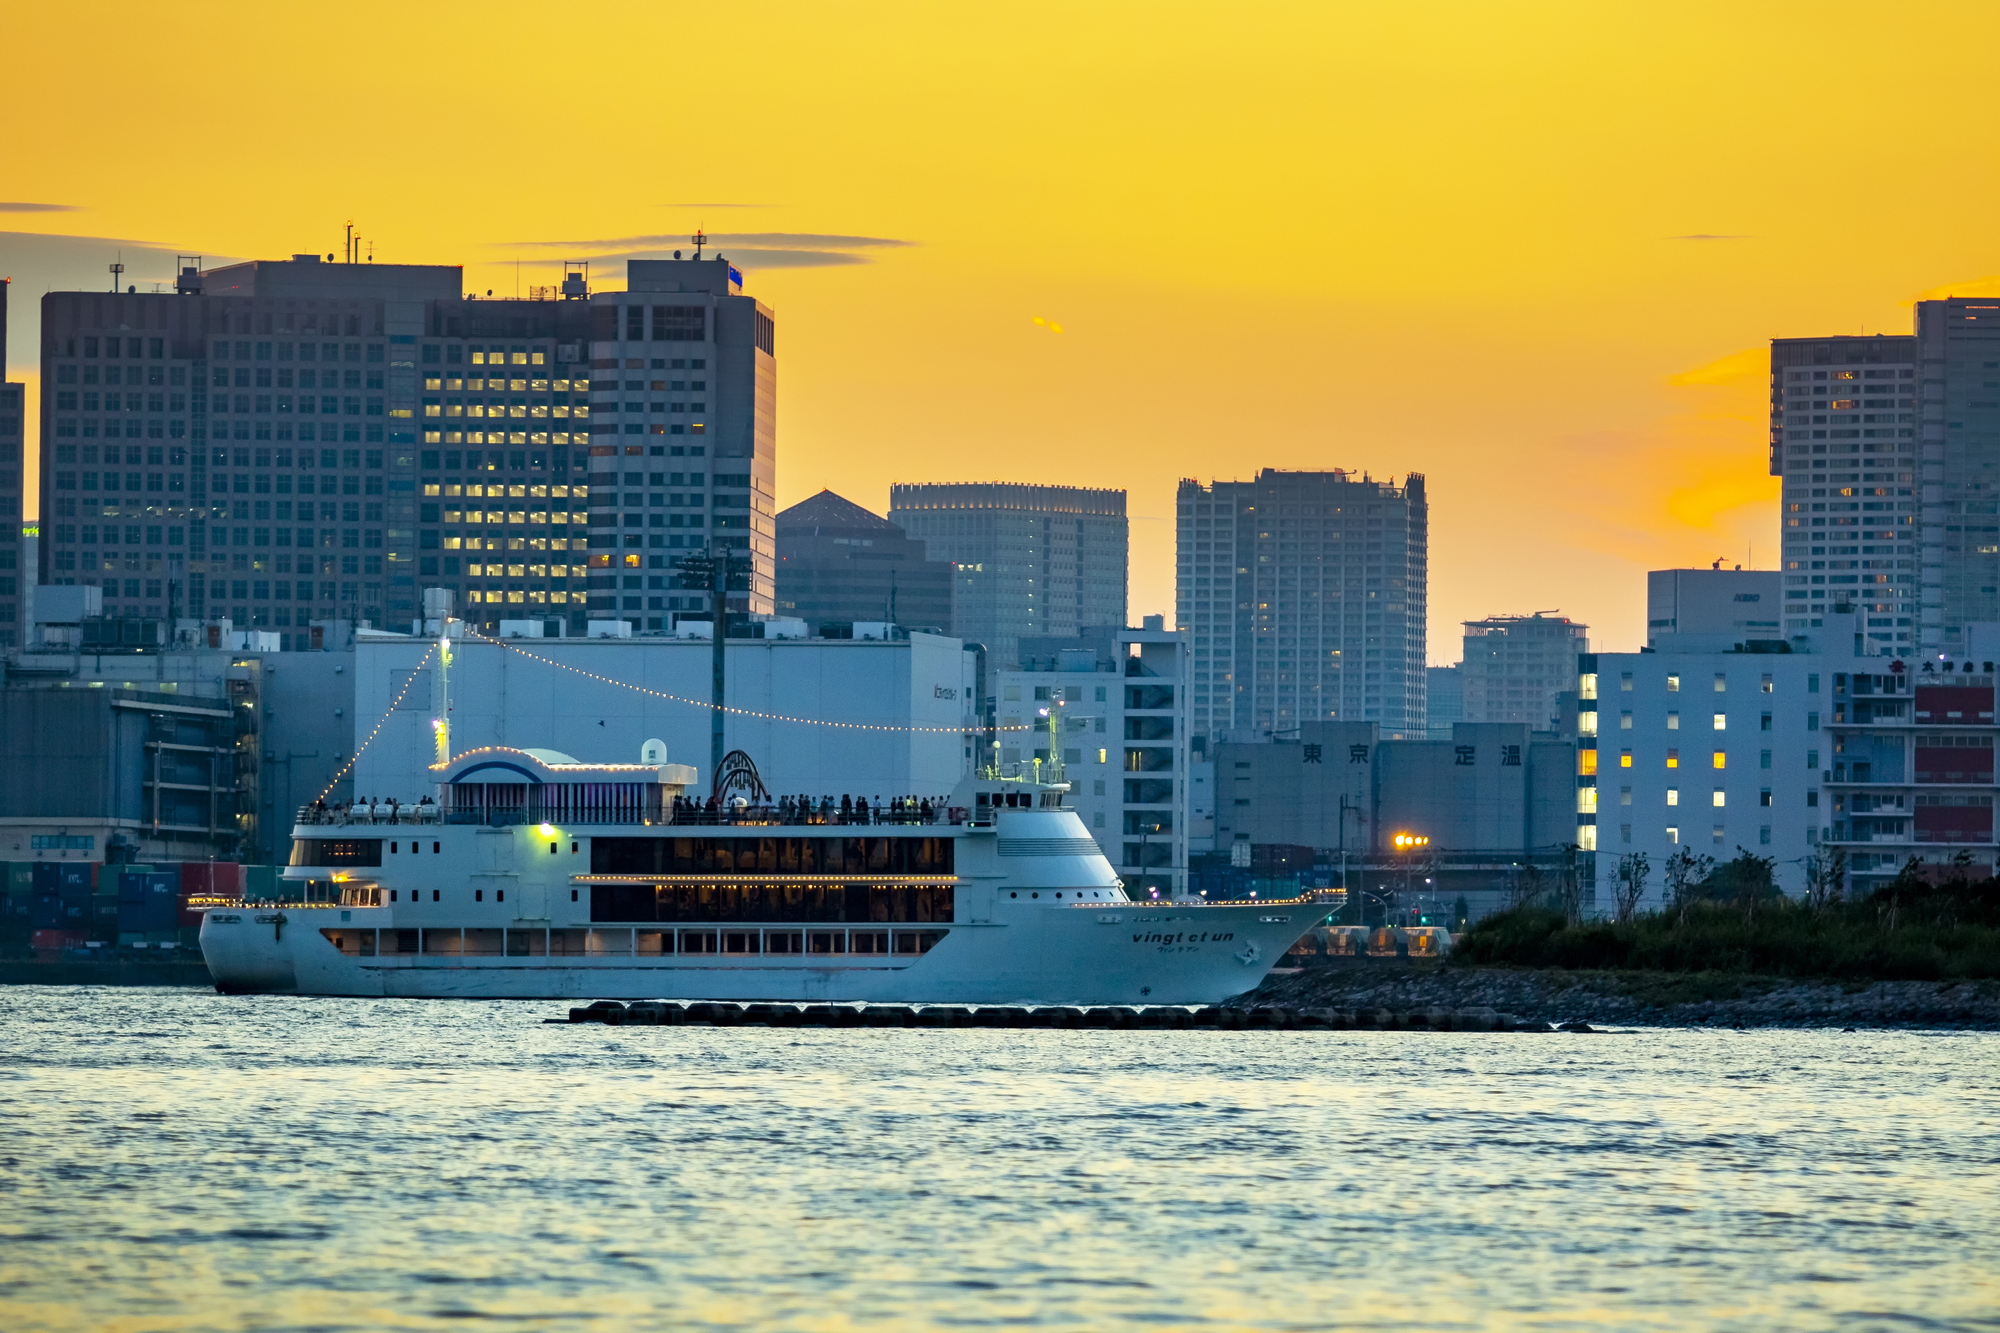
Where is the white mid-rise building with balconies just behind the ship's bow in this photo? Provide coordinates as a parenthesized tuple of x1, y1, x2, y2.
(994, 616, 1192, 897)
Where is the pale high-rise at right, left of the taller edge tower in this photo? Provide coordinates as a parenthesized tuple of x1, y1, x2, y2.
(1770, 330, 1920, 654)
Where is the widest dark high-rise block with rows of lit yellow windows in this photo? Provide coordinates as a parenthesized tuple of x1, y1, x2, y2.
(40, 254, 776, 648)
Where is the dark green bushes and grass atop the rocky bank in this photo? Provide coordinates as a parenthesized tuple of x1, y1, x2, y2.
(1452, 849, 2000, 981)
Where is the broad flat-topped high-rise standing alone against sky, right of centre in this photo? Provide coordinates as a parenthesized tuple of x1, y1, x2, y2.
(1176, 468, 1430, 741)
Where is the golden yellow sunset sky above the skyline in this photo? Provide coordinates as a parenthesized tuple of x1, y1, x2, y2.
(0, 0, 2000, 662)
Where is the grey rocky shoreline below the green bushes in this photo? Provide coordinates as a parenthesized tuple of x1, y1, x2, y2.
(1230, 963, 2000, 1029)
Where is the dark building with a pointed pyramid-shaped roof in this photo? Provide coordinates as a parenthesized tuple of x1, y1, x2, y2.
(778, 490, 952, 634)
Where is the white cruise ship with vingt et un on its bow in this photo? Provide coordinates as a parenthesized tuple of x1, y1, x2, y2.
(200, 743, 1318, 1005)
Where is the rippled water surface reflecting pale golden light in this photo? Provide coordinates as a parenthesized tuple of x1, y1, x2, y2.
(0, 987, 2000, 1333)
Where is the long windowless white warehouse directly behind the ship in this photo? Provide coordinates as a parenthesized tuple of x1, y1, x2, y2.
(350, 630, 976, 803)
